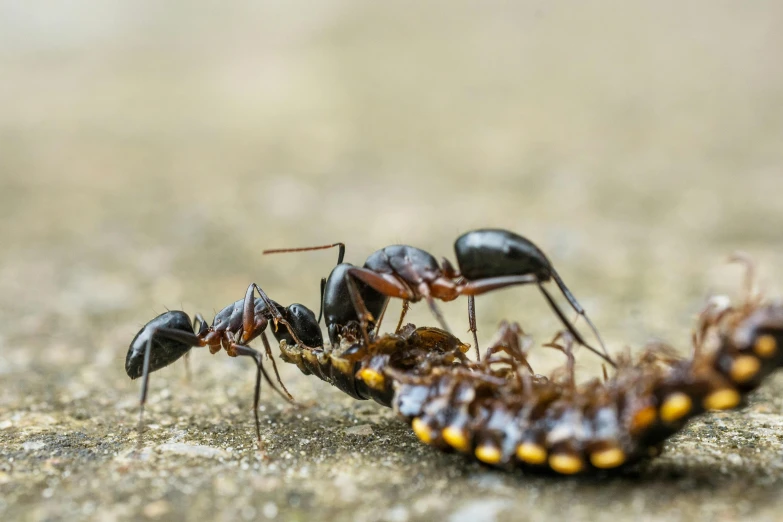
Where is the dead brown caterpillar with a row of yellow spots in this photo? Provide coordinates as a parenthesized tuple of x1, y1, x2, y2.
(281, 268, 783, 475)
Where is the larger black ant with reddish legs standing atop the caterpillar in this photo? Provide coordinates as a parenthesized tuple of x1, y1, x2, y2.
(264, 229, 614, 366)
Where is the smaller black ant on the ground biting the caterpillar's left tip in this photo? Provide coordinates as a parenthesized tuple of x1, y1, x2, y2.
(125, 283, 323, 447)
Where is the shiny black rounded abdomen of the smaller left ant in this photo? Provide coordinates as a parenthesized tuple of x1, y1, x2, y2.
(125, 310, 195, 379)
